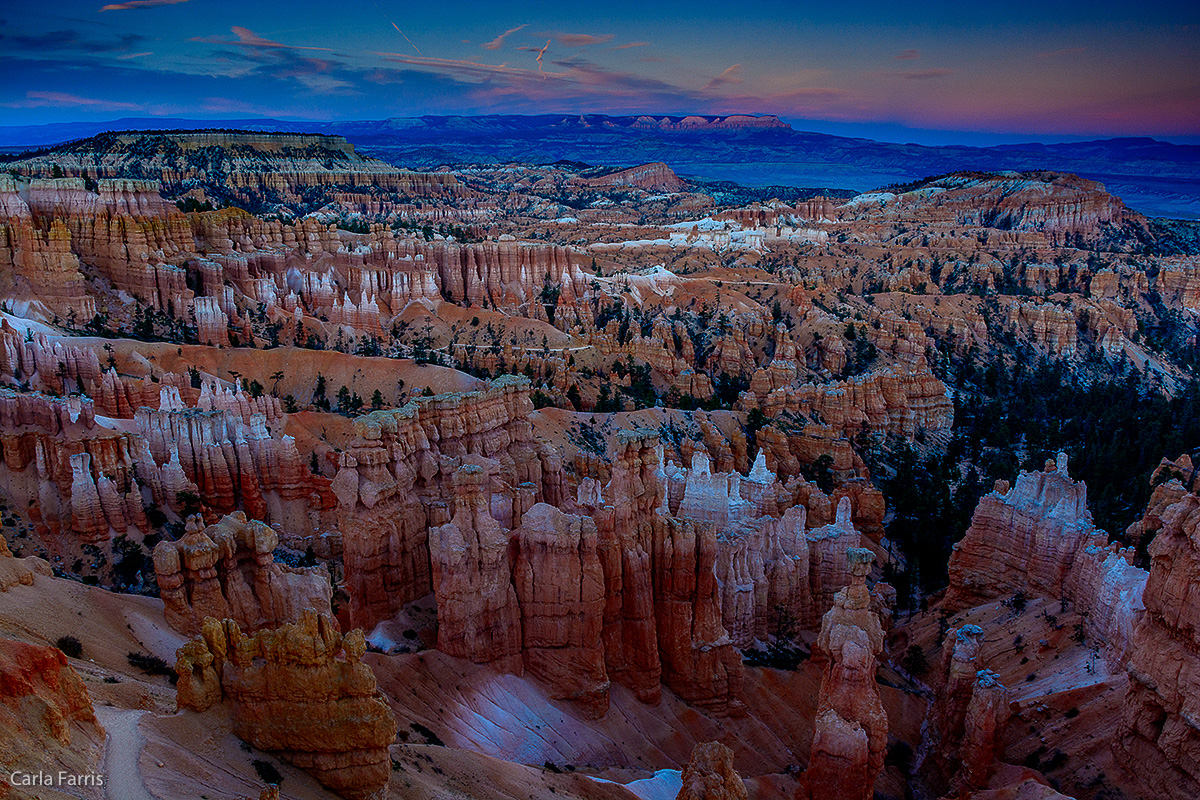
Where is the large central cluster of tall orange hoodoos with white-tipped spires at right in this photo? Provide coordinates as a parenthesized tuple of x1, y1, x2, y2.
(332, 379, 882, 716)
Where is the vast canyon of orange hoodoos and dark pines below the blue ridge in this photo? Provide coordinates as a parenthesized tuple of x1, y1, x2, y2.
(0, 126, 1200, 800)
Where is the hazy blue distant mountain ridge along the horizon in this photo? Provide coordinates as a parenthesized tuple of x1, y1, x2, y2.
(0, 114, 1200, 218)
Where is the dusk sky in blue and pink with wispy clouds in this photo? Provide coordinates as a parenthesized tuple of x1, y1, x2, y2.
(0, 0, 1200, 144)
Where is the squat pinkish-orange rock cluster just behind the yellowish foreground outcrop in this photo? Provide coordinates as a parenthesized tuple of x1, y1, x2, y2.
(154, 511, 332, 633)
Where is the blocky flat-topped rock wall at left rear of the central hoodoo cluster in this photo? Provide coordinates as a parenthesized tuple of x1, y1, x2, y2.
(332, 378, 549, 628)
